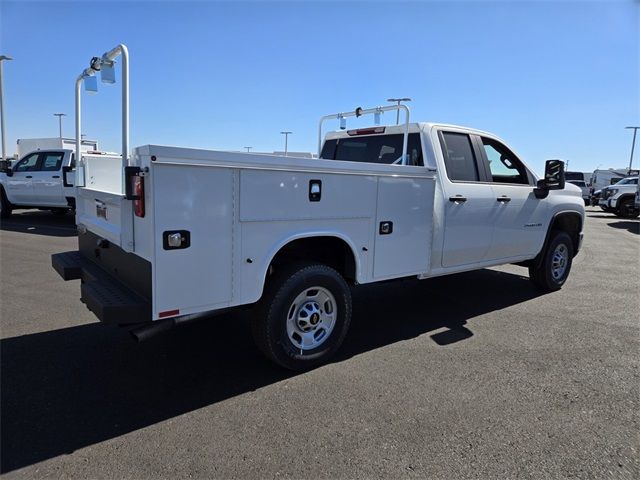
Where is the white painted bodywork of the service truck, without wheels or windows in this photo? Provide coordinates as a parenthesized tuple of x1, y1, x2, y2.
(66, 124, 584, 320)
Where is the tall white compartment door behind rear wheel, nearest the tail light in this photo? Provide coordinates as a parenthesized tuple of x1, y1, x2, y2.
(151, 163, 234, 318)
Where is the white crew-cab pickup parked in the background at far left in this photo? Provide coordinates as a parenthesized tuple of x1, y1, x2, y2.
(0, 149, 75, 218)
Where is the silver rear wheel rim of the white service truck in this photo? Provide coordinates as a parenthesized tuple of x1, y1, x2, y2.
(287, 287, 338, 351)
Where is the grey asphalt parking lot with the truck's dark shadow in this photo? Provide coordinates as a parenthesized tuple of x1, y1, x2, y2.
(0, 208, 640, 478)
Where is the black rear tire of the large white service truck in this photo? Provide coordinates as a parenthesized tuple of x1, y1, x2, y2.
(251, 263, 351, 371)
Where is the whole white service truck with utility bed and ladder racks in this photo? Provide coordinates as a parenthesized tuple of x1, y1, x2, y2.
(52, 45, 584, 369)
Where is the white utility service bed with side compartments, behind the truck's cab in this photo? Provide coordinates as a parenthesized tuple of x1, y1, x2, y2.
(124, 146, 435, 318)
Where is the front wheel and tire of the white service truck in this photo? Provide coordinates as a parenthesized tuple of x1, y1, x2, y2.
(529, 232, 573, 292)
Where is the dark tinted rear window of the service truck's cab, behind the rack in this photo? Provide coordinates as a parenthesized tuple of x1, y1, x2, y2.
(320, 133, 423, 166)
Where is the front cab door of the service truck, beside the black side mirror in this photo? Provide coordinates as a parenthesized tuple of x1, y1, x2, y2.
(479, 137, 548, 260)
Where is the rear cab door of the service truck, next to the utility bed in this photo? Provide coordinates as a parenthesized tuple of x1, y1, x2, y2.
(439, 131, 496, 267)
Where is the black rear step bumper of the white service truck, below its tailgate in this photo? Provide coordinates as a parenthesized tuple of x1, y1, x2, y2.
(51, 251, 151, 324)
